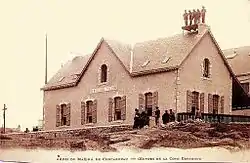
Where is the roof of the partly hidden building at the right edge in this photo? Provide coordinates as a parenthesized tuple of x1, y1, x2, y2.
(223, 46, 250, 76)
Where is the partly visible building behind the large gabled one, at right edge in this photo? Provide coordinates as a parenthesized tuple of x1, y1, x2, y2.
(223, 46, 250, 116)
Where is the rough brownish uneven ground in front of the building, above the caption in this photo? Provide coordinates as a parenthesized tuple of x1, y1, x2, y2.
(0, 121, 250, 152)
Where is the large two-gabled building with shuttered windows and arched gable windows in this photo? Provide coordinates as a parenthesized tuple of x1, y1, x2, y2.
(42, 24, 237, 130)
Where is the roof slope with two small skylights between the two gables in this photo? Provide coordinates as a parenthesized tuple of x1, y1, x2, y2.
(132, 33, 204, 74)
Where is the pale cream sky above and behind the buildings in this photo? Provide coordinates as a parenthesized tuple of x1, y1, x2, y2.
(0, 0, 250, 129)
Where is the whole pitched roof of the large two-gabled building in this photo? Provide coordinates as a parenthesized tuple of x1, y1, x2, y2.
(42, 24, 238, 90)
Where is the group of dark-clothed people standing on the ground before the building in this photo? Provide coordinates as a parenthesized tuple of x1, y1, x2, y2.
(133, 107, 175, 129)
